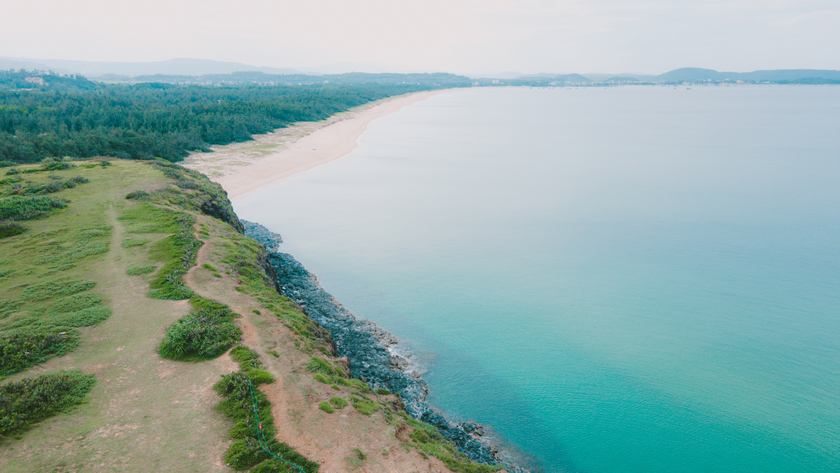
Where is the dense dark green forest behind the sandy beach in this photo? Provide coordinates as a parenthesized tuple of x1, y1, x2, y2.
(0, 71, 467, 163)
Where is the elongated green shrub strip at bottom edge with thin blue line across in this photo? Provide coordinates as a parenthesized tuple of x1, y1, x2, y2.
(214, 347, 319, 473)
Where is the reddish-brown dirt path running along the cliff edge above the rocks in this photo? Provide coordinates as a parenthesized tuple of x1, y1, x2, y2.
(185, 217, 449, 473)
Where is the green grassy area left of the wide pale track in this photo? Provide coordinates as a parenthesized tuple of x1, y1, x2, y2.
(0, 163, 112, 376)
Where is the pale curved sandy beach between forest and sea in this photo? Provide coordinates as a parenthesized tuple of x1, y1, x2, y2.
(181, 89, 451, 198)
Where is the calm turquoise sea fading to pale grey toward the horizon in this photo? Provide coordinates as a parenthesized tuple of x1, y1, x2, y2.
(234, 86, 840, 473)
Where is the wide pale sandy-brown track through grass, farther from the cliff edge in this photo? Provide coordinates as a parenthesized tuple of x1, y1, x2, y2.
(0, 201, 235, 472)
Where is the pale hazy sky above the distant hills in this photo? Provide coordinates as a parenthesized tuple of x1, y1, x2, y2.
(0, 0, 840, 73)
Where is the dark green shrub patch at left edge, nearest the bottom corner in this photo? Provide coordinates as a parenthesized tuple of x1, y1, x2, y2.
(0, 371, 96, 439)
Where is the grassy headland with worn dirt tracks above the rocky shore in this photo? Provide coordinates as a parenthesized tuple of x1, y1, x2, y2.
(0, 160, 506, 473)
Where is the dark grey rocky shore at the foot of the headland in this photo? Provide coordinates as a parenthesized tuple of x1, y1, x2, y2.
(242, 221, 528, 473)
